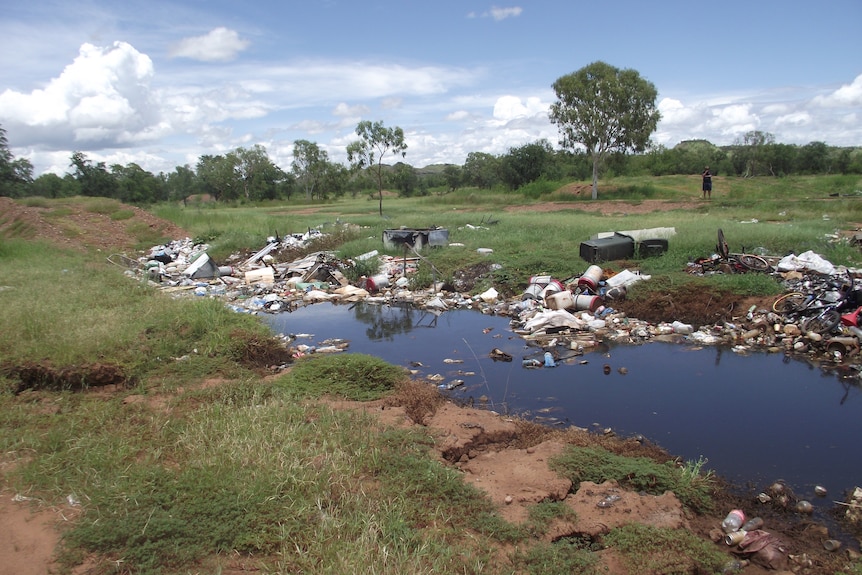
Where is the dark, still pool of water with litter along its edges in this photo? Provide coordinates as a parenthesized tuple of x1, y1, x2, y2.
(265, 303, 862, 514)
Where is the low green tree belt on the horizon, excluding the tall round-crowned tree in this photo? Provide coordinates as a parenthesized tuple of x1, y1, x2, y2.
(0, 127, 862, 208)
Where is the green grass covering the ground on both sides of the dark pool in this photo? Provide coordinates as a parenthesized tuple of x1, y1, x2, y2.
(5, 179, 862, 574)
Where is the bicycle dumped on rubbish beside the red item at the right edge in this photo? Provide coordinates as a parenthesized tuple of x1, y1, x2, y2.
(772, 271, 860, 335)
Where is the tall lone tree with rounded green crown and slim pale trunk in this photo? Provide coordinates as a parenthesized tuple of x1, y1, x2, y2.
(549, 62, 661, 199)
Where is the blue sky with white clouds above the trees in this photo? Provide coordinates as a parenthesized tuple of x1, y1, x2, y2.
(0, 0, 862, 175)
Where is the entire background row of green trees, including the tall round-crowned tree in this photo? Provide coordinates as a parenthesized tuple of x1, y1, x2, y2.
(0, 62, 862, 205)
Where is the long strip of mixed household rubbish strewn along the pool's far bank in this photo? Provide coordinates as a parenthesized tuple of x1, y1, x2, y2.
(120, 230, 862, 371)
